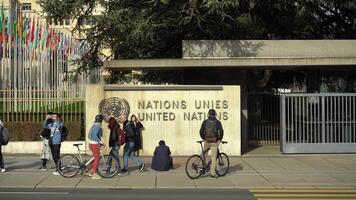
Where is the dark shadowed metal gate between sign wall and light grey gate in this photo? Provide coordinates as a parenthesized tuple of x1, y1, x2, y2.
(248, 93, 280, 145)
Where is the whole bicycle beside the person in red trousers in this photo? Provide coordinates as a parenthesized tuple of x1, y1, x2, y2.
(57, 144, 119, 178)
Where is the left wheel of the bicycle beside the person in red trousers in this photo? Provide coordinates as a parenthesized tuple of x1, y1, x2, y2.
(57, 154, 80, 178)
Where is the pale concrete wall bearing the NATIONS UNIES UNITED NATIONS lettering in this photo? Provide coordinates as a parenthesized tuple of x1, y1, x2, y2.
(86, 85, 241, 156)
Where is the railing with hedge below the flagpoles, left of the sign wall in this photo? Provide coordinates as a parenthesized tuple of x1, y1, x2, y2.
(0, 89, 85, 141)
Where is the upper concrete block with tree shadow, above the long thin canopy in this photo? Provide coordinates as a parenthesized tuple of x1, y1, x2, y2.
(182, 40, 356, 58)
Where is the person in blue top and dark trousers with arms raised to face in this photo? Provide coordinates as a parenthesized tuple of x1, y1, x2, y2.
(43, 113, 63, 176)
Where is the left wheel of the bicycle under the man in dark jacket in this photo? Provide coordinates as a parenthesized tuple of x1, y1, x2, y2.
(185, 155, 204, 179)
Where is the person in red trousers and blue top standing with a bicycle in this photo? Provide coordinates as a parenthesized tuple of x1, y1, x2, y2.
(88, 115, 104, 179)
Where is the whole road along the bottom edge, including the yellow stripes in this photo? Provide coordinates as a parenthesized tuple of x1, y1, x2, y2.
(0, 189, 356, 200)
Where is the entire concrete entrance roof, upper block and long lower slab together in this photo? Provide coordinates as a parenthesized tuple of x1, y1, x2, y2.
(105, 40, 356, 70)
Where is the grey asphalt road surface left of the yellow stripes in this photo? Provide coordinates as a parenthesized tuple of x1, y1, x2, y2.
(0, 189, 256, 200)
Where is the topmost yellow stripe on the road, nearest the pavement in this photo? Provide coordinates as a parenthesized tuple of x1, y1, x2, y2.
(249, 189, 356, 193)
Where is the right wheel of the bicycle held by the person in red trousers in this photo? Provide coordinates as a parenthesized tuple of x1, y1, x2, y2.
(98, 155, 119, 178)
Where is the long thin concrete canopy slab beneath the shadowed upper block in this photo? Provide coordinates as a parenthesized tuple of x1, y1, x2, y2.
(104, 57, 356, 70)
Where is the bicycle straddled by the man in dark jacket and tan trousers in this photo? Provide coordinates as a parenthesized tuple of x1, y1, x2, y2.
(185, 141, 230, 179)
